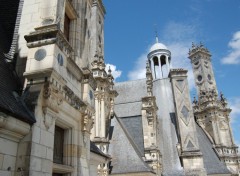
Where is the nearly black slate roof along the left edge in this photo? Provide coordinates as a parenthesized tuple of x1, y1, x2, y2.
(0, 0, 36, 124)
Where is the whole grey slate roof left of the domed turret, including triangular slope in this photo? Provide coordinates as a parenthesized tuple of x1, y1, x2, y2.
(109, 79, 153, 174)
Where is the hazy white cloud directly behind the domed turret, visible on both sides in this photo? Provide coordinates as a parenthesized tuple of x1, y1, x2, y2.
(128, 22, 196, 90)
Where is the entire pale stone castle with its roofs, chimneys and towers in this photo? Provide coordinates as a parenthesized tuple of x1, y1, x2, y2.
(0, 0, 240, 176)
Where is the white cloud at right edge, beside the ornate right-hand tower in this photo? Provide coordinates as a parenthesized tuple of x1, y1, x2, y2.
(221, 31, 240, 64)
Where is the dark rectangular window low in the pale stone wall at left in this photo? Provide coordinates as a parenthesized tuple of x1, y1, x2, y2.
(53, 126, 64, 164)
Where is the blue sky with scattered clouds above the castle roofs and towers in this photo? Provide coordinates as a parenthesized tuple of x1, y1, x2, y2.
(104, 0, 240, 145)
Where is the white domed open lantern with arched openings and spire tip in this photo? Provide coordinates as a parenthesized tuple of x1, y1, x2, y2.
(147, 37, 171, 79)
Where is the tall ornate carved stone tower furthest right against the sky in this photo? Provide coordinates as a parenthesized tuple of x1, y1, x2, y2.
(189, 43, 239, 173)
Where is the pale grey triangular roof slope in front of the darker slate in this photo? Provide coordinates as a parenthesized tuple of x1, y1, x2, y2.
(109, 117, 153, 174)
